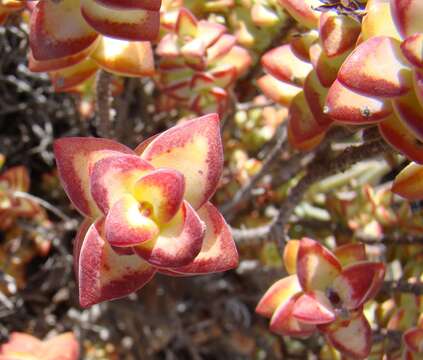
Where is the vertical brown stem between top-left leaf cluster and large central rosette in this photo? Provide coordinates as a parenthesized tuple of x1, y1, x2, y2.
(96, 70, 112, 138)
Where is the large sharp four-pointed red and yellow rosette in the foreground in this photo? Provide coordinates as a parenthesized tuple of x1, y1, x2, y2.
(54, 114, 238, 307)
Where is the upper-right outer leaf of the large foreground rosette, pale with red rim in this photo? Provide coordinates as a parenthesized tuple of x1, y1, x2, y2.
(141, 114, 223, 209)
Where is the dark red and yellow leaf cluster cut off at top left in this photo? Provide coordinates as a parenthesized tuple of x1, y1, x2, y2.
(29, 0, 160, 91)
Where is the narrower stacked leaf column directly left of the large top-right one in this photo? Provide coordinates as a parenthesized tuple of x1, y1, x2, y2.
(257, 0, 361, 150)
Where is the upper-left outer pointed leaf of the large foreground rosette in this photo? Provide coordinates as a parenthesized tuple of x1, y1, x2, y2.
(53, 137, 133, 217)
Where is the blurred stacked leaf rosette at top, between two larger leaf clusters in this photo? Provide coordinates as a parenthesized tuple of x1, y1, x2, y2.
(156, 8, 251, 114)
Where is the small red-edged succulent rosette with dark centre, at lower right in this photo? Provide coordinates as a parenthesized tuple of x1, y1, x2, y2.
(256, 238, 385, 359)
